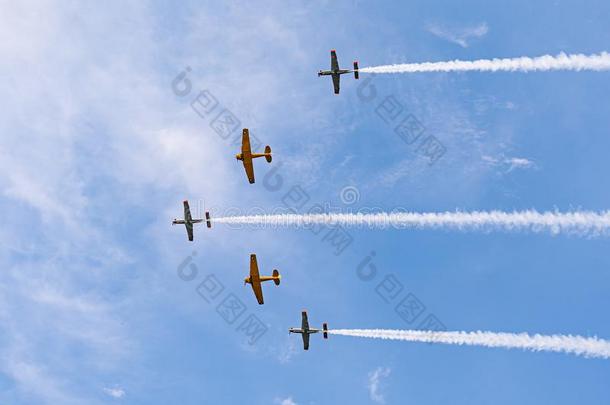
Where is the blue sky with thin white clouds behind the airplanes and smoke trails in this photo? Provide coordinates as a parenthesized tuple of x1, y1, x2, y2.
(0, 0, 610, 405)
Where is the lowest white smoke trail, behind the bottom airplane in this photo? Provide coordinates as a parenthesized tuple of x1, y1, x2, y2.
(328, 329, 610, 359)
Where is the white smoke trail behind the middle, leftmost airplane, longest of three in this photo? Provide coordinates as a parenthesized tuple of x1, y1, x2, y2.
(212, 211, 610, 236)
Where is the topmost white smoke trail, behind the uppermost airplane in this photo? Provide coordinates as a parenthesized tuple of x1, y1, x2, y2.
(360, 52, 610, 73)
